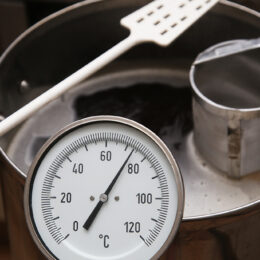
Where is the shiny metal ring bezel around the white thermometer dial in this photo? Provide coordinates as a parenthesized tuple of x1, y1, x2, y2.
(24, 115, 184, 260)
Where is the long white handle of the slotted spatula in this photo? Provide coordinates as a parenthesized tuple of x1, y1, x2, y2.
(0, 35, 137, 136)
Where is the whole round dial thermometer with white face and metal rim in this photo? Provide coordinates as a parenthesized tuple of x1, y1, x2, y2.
(24, 116, 184, 260)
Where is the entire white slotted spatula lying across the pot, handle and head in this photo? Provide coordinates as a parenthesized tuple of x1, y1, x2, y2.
(0, 0, 218, 136)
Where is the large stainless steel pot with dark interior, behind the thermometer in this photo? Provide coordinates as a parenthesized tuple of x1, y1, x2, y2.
(0, 0, 260, 260)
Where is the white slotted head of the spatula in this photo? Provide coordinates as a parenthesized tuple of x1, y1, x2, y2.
(121, 0, 218, 46)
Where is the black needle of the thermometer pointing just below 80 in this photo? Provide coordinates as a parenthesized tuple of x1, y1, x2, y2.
(83, 149, 134, 230)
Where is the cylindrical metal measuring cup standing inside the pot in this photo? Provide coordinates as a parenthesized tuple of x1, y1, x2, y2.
(190, 38, 260, 178)
